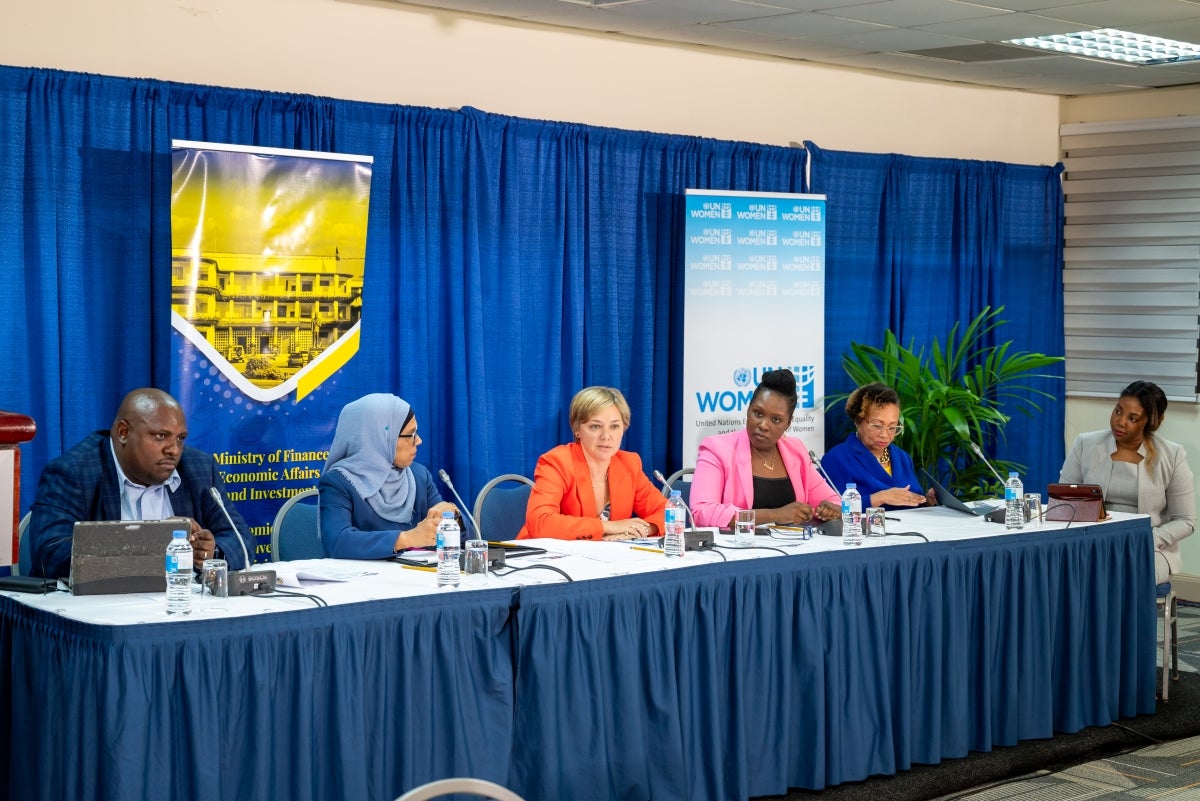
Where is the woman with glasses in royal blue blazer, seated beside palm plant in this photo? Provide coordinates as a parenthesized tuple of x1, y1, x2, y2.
(821, 384, 937, 508)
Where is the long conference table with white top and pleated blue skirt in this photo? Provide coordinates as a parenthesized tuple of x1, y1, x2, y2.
(0, 508, 1156, 801)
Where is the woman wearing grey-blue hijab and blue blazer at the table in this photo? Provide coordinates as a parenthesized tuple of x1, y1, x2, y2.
(317, 393, 457, 559)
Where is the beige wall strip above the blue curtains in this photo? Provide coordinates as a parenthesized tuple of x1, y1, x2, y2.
(7, 0, 1058, 164)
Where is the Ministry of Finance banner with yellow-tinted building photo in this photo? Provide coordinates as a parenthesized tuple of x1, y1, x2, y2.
(172, 140, 372, 561)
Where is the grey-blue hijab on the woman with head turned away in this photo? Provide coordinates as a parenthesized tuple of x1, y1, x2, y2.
(325, 393, 416, 523)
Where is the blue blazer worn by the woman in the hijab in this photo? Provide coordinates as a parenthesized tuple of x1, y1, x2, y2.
(317, 462, 446, 559)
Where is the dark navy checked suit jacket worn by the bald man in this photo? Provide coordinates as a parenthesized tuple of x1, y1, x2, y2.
(25, 430, 254, 578)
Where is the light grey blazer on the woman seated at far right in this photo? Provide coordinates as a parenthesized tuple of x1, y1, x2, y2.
(1058, 429, 1196, 574)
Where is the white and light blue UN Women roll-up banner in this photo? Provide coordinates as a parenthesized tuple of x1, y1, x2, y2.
(682, 189, 826, 466)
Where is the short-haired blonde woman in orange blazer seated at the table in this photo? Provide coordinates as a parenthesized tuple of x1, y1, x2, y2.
(517, 386, 667, 540)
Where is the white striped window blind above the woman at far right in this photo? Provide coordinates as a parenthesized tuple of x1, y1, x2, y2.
(1060, 116, 1200, 402)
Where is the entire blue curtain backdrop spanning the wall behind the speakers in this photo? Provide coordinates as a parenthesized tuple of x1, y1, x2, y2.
(0, 67, 1062, 522)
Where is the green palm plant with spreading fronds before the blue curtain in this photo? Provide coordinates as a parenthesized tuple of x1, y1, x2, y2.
(826, 306, 1063, 499)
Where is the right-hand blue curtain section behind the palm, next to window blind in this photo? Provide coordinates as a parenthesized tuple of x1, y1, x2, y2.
(805, 143, 1066, 490)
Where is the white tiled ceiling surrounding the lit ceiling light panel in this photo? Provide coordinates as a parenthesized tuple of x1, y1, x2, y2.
(395, 0, 1200, 94)
